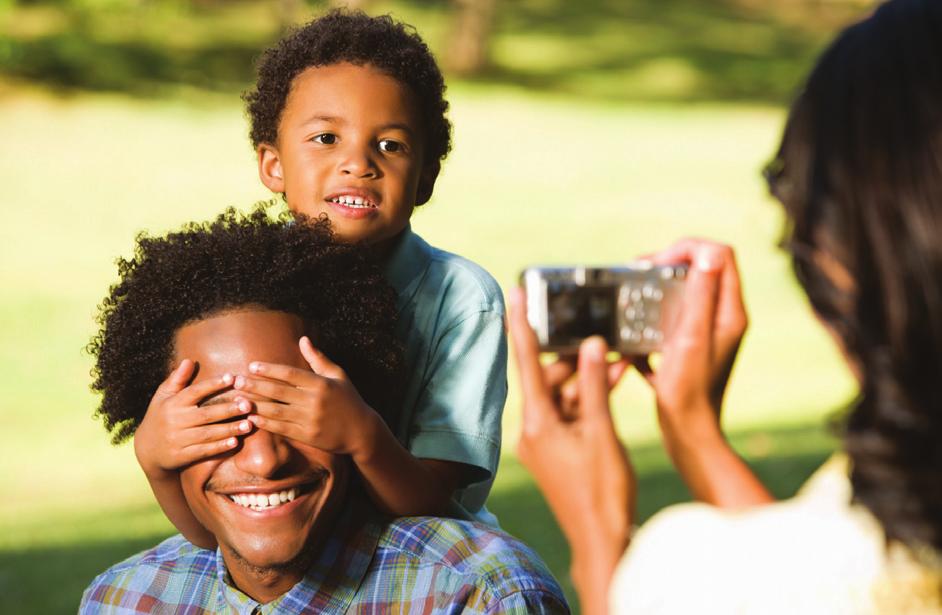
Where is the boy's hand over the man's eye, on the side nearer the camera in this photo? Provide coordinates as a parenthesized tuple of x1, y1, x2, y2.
(234, 336, 378, 458)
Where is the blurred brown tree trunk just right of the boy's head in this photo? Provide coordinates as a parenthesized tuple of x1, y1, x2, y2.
(445, 0, 497, 75)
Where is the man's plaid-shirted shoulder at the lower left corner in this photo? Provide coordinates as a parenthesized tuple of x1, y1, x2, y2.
(79, 535, 216, 613)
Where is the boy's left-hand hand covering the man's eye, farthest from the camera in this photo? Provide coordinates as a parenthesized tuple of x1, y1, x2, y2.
(134, 359, 252, 478)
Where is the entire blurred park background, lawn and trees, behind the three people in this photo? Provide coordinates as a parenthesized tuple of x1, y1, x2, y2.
(0, 0, 870, 614)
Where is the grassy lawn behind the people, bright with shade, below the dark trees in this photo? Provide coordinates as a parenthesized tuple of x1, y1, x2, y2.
(0, 87, 851, 614)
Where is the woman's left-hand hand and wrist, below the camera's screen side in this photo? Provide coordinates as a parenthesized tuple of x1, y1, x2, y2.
(510, 289, 635, 613)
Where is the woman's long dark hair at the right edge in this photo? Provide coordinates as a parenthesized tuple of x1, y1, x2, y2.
(767, 0, 942, 553)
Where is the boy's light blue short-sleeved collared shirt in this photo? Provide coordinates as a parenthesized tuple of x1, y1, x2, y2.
(386, 227, 507, 526)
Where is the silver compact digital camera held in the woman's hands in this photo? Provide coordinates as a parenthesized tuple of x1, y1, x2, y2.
(520, 263, 687, 355)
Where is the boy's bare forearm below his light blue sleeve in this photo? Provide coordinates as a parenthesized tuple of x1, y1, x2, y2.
(351, 415, 458, 516)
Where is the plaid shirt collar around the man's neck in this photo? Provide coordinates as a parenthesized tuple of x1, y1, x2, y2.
(216, 498, 383, 615)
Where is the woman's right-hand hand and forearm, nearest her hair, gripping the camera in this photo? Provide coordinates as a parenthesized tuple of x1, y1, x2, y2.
(635, 239, 772, 508)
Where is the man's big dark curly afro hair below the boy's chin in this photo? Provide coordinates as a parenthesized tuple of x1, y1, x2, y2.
(88, 206, 402, 443)
